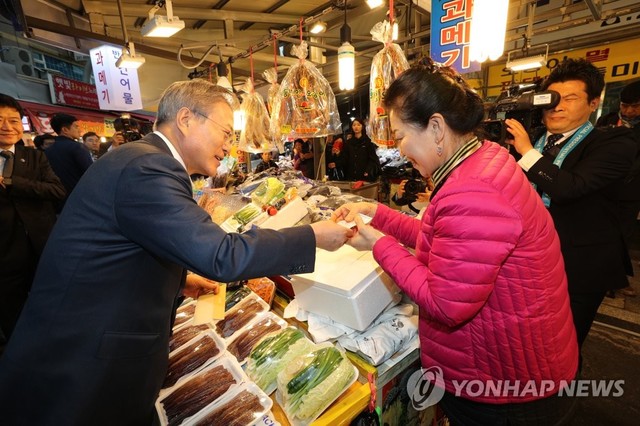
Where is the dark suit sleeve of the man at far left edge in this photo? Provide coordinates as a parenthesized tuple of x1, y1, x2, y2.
(11, 150, 67, 201)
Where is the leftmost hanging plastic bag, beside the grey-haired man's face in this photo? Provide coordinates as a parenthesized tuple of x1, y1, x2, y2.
(238, 78, 278, 153)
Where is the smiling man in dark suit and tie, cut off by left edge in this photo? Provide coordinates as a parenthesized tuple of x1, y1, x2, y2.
(0, 94, 65, 353)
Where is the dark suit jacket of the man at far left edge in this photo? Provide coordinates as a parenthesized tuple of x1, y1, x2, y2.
(0, 145, 65, 261)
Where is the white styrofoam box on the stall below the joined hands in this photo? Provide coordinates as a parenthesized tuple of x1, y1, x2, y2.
(290, 245, 400, 331)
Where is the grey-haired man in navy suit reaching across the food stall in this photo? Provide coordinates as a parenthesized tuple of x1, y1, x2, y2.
(0, 79, 352, 425)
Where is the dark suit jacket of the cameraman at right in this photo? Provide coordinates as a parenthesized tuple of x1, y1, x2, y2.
(527, 125, 636, 294)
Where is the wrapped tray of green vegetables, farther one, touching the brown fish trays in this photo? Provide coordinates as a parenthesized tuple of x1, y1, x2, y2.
(245, 327, 315, 394)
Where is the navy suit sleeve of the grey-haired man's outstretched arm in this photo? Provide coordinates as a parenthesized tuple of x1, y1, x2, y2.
(115, 154, 315, 282)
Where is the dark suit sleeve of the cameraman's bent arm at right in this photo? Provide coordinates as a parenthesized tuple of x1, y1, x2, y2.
(527, 129, 637, 203)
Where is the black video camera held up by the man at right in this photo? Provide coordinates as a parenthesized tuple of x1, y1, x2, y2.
(481, 83, 560, 145)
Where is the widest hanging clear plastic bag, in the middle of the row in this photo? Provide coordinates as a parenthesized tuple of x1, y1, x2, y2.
(271, 41, 342, 139)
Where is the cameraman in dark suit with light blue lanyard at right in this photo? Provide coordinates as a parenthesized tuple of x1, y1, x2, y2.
(505, 59, 636, 354)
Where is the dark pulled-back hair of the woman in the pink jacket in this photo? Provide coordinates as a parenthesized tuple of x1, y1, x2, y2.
(384, 58, 484, 134)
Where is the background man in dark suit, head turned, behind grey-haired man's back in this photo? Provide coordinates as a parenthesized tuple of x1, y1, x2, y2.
(44, 114, 93, 200)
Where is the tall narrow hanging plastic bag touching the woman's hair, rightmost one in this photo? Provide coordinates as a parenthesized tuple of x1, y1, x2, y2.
(368, 21, 409, 147)
